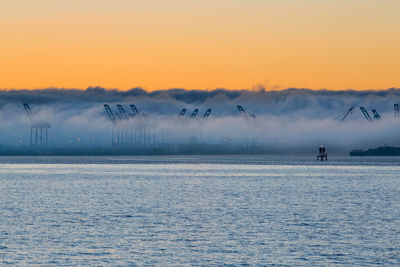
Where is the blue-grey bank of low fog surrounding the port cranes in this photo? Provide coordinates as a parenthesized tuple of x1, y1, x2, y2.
(0, 87, 400, 153)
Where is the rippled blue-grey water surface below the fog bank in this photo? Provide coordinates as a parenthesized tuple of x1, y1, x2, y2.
(0, 156, 400, 266)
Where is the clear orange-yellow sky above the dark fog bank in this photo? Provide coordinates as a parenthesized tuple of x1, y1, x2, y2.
(0, 0, 400, 90)
